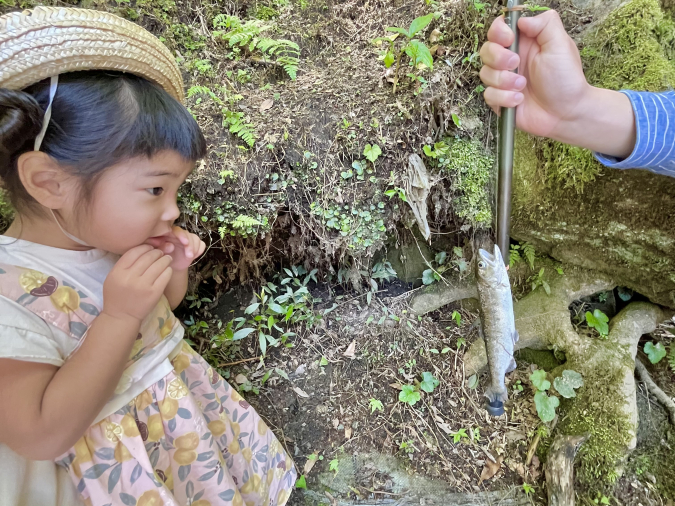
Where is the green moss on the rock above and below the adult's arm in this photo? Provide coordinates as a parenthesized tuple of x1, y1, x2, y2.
(515, 0, 675, 202)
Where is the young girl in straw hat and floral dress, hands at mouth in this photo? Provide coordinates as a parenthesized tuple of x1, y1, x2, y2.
(0, 8, 296, 506)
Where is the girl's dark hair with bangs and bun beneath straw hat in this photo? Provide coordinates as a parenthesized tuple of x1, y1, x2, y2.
(0, 71, 206, 211)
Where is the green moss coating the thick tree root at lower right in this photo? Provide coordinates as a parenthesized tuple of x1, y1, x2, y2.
(557, 360, 635, 493)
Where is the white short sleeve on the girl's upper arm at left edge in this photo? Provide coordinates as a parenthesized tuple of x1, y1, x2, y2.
(0, 296, 66, 367)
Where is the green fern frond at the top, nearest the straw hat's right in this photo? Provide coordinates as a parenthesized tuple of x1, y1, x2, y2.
(213, 14, 300, 80)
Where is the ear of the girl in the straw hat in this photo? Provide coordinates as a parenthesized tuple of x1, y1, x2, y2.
(17, 151, 76, 209)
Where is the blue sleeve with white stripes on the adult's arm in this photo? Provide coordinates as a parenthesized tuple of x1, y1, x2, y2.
(595, 90, 675, 177)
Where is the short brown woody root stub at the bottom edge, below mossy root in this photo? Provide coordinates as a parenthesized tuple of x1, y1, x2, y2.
(546, 434, 589, 506)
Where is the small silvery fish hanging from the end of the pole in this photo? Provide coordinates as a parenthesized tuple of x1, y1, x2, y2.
(476, 244, 518, 413)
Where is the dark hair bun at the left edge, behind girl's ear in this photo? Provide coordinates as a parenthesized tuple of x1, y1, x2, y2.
(0, 88, 44, 163)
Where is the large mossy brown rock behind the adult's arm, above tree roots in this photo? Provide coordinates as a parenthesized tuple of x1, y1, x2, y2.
(512, 0, 675, 307)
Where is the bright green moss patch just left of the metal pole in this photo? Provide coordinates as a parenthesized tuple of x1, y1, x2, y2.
(439, 139, 494, 228)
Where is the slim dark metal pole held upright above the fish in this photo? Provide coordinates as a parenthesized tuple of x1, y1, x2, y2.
(497, 0, 522, 265)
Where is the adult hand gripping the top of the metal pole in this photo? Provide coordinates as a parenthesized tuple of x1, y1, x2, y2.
(480, 10, 592, 140)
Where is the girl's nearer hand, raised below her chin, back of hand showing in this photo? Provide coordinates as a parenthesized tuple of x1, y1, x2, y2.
(103, 244, 173, 321)
